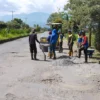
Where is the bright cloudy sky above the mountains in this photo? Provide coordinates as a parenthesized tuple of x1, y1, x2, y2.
(0, 0, 67, 15)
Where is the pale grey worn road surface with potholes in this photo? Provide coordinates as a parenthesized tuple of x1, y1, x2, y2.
(0, 38, 100, 100)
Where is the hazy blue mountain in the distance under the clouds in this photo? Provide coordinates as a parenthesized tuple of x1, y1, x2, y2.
(0, 12, 50, 27)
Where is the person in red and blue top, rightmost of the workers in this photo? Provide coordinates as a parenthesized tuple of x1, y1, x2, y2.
(79, 32, 88, 63)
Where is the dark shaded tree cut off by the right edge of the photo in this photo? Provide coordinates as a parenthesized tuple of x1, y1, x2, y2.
(89, 0, 100, 51)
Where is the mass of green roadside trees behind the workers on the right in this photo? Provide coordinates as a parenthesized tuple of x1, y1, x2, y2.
(47, 0, 100, 52)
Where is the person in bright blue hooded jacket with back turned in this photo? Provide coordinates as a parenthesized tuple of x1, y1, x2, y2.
(50, 28, 58, 59)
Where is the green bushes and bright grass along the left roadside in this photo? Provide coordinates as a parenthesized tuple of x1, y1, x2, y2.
(0, 18, 30, 41)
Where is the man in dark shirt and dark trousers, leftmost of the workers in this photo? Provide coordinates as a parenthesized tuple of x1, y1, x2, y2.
(29, 29, 40, 60)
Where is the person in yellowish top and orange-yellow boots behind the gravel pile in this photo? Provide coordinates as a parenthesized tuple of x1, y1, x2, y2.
(68, 30, 74, 57)
